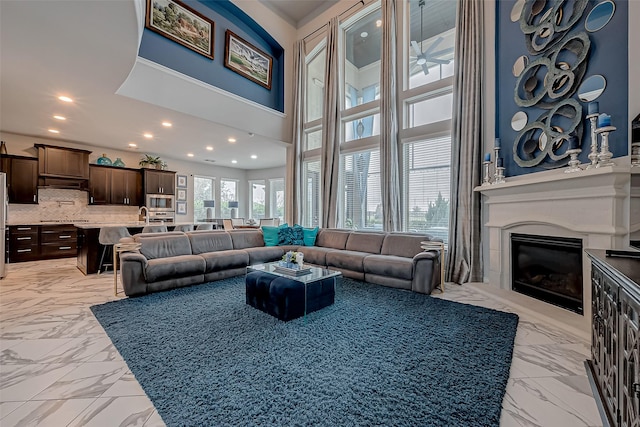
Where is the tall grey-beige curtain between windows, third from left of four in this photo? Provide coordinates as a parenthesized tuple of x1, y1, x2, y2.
(380, 0, 401, 231)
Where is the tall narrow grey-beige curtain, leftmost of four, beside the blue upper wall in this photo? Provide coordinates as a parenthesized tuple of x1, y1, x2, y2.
(285, 40, 305, 224)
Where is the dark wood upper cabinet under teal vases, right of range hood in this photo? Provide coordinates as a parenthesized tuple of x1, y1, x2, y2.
(89, 165, 142, 206)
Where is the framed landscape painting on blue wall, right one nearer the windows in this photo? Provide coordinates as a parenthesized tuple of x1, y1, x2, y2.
(224, 30, 273, 90)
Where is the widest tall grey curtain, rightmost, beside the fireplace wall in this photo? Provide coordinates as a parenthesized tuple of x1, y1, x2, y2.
(446, 0, 484, 283)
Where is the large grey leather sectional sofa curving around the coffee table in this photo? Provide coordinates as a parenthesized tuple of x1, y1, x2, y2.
(120, 229, 440, 296)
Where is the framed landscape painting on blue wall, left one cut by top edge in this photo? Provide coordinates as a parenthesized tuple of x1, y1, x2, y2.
(145, 0, 215, 59)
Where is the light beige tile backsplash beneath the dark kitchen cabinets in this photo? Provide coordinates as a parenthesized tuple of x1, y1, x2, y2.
(7, 188, 138, 225)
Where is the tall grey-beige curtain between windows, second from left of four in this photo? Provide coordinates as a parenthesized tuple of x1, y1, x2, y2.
(320, 17, 341, 228)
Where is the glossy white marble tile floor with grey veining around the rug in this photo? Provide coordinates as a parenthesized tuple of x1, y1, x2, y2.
(0, 259, 602, 427)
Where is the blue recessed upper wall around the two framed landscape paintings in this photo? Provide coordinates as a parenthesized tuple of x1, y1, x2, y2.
(138, 0, 284, 112)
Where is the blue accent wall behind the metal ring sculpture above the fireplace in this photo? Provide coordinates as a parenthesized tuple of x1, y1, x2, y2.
(491, 0, 629, 176)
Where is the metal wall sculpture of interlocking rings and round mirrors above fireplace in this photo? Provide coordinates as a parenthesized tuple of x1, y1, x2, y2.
(511, 0, 591, 167)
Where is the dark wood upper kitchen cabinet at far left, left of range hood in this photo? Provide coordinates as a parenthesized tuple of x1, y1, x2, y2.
(2, 156, 38, 204)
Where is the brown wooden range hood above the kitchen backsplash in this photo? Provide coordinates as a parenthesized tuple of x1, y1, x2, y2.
(35, 144, 91, 190)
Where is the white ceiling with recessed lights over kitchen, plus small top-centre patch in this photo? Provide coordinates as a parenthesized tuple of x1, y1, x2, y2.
(0, 0, 324, 169)
